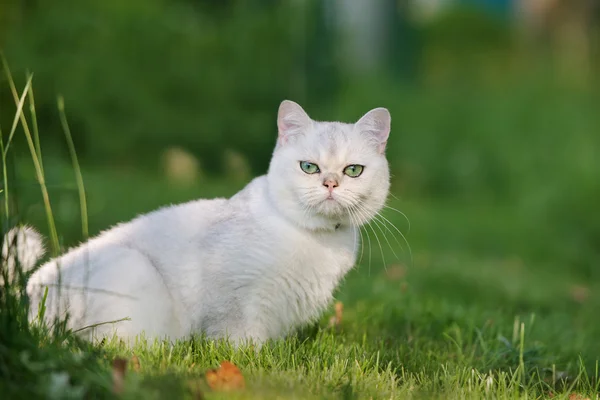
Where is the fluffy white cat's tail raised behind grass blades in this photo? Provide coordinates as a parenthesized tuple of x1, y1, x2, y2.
(0, 226, 46, 283)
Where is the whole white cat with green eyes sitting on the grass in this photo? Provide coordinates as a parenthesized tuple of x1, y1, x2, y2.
(4, 100, 391, 343)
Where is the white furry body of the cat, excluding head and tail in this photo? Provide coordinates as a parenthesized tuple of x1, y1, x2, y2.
(28, 176, 356, 339)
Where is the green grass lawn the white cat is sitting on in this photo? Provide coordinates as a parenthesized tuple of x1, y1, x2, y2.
(0, 167, 600, 399)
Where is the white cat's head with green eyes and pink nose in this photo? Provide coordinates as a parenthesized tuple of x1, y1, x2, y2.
(268, 100, 391, 229)
